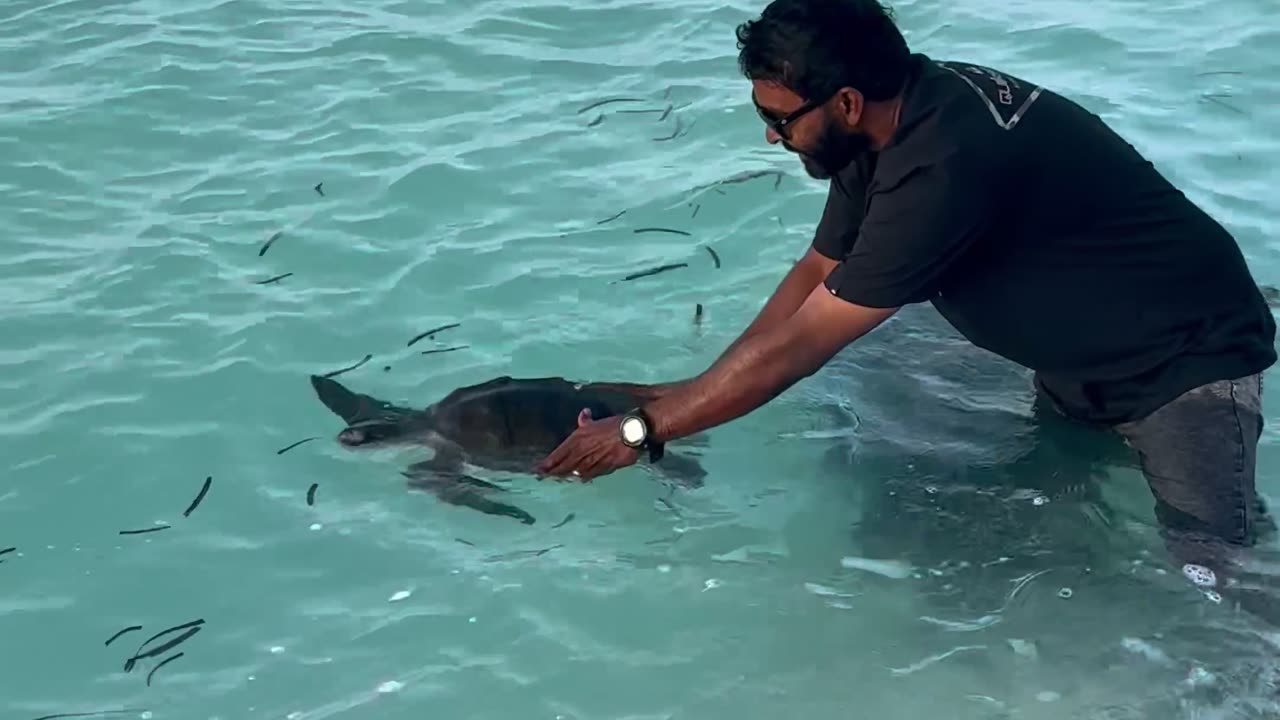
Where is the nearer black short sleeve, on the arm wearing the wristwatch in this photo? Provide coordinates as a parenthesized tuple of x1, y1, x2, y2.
(824, 150, 997, 307)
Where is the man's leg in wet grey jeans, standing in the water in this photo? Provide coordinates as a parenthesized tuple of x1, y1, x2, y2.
(1115, 375, 1275, 597)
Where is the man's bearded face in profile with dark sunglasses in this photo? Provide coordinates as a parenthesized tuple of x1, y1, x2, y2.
(751, 81, 870, 179)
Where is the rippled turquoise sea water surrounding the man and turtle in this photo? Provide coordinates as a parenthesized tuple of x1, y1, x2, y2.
(0, 0, 1280, 720)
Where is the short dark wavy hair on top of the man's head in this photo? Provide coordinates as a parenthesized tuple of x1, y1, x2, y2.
(736, 0, 910, 100)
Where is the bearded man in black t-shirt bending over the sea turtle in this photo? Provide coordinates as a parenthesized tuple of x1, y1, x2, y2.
(538, 0, 1276, 584)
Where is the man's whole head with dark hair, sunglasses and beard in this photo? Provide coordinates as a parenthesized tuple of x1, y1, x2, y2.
(736, 0, 910, 178)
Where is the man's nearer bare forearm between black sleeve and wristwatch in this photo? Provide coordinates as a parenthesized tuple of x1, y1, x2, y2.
(644, 281, 897, 442)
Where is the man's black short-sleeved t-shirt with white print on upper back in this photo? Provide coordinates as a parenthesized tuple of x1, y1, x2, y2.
(813, 54, 1276, 423)
